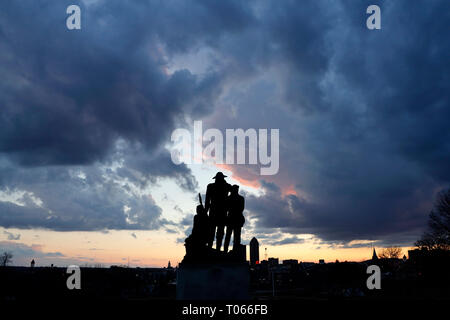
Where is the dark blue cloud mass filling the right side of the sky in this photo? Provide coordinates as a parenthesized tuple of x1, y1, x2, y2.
(288, 2, 450, 244)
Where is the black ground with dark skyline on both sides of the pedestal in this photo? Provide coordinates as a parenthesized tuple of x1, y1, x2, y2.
(0, 254, 450, 301)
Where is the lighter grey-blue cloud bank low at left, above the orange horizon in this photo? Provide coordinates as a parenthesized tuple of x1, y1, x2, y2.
(0, 158, 170, 231)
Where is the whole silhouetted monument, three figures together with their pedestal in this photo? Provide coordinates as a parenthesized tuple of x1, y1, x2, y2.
(177, 172, 249, 300)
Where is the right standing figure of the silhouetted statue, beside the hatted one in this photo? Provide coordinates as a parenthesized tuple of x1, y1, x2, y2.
(223, 184, 245, 252)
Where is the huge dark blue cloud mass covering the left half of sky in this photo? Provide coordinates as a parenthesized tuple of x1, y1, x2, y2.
(0, 1, 253, 231)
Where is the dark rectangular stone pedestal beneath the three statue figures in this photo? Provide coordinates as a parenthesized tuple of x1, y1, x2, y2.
(177, 263, 250, 300)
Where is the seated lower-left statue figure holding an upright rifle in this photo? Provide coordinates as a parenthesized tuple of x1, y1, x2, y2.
(185, 194, 211, 260)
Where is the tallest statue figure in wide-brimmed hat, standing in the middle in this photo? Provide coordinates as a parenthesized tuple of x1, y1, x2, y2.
(205, 172, 231, 251)
